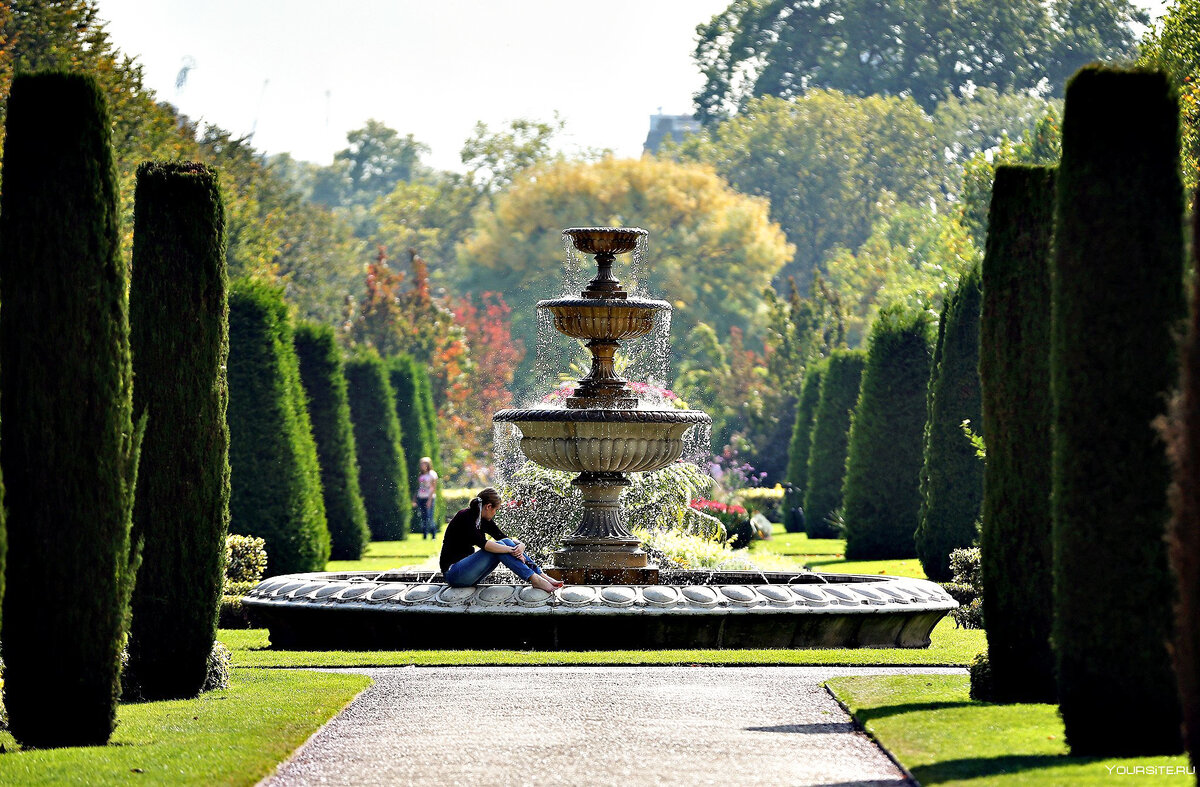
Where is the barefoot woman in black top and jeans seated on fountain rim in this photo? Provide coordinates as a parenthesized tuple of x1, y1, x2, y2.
(442, 487, 563, 593)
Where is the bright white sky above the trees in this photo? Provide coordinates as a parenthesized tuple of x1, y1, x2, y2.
(98, 0, 1163, 169)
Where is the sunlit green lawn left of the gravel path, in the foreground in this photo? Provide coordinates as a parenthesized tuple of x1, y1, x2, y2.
(0, 669, 371, 785)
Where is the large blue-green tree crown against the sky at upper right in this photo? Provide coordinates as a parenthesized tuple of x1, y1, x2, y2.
(692, 0, 1148, 121)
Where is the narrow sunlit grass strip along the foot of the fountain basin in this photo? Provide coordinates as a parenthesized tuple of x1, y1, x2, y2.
(218, 619, 986, 667)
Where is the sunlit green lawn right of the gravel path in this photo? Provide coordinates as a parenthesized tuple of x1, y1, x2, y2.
(828, 675, 1193, 787)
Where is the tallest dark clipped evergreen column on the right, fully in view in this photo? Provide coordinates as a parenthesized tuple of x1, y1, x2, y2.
(1050, 66, 1194, 756)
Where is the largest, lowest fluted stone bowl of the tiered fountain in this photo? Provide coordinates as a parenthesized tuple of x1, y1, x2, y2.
(492, 408, 713, 473)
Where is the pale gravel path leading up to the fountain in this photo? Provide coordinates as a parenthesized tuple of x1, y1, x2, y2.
(264, 667, 962, 787)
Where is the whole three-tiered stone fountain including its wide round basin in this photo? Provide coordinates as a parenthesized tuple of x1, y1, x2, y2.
(244, 228, 958, 650)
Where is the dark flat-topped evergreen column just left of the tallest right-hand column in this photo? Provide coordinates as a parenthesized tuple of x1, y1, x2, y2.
(979, 167, 1056, 702)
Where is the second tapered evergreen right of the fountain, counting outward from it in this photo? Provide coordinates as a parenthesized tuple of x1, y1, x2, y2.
(804, 350, 866, 539)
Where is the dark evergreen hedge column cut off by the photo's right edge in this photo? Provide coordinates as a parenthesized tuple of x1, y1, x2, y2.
(1165, 203, 1200, 767)
